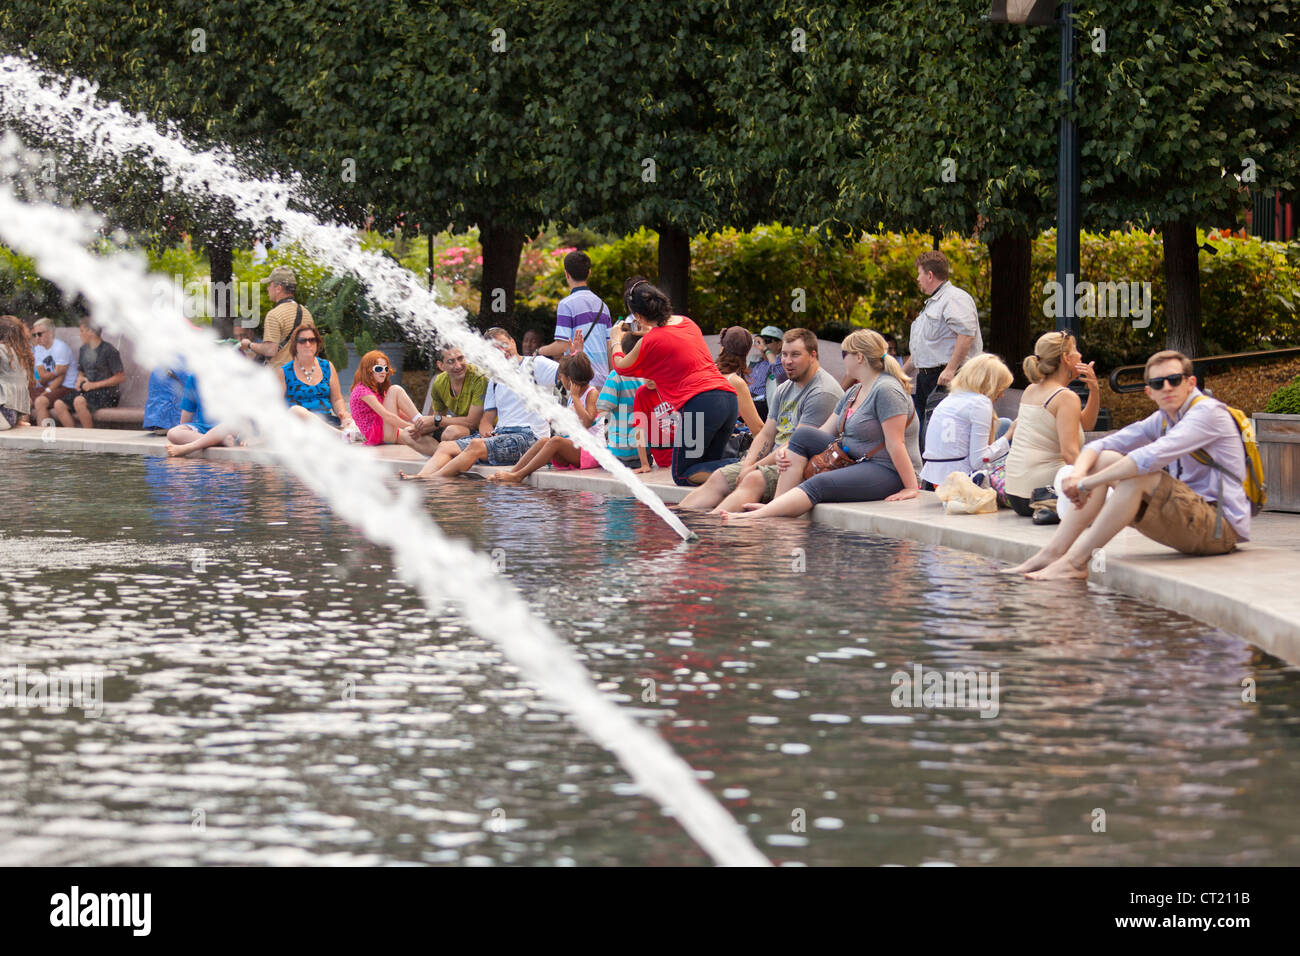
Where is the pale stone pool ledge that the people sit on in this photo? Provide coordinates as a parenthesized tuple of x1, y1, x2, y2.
(0, 428, 1300, 663)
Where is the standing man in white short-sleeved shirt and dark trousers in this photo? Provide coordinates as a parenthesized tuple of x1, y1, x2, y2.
(902, 248, 984, 451)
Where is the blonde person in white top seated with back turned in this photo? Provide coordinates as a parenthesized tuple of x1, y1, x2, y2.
(920, 352, 1015, 488)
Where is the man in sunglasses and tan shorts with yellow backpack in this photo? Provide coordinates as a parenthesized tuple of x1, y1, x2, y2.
(1009, 351, 1251, 580)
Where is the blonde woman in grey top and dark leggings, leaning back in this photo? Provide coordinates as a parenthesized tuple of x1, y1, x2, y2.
(723, 329, 920, 520)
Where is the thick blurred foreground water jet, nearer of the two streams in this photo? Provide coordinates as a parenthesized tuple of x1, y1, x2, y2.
(0, 134, 767, 865)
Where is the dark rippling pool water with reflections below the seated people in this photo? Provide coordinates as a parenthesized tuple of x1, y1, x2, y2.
(0, 451, 1300, 865)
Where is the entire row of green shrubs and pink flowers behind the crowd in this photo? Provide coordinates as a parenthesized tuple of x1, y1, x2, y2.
(10, 225, 1300, 368)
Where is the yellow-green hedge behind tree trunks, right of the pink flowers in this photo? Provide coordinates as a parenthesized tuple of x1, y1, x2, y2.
(519, 225, 1300, 368)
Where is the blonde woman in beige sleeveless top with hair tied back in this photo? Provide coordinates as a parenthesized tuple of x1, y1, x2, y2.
(1006, 332, 1099, 518)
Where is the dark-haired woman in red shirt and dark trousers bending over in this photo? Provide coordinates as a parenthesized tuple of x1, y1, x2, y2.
(610, 276, 740, 485)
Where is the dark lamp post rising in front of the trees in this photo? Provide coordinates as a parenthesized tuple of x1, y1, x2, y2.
(988, 0, 1082, 341)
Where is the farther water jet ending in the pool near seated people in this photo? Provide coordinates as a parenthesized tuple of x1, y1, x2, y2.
(0, 56, 693, 541)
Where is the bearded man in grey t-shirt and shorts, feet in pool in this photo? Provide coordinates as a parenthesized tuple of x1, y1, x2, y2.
(681, 329, 844, 514)
